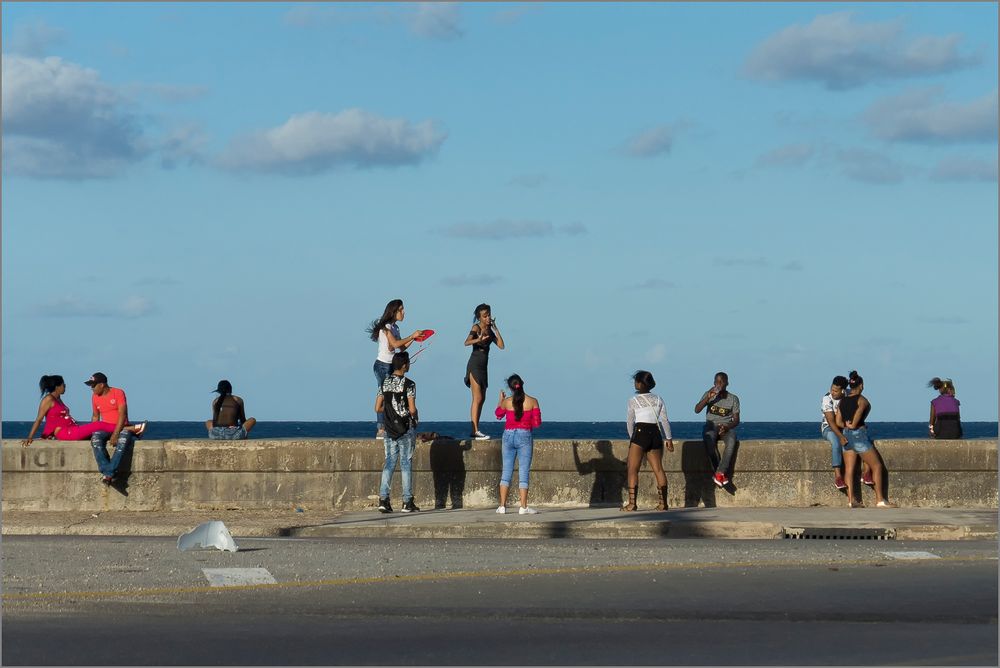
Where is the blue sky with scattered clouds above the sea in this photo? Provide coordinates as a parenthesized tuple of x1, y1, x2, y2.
(0, 2, 998, 423)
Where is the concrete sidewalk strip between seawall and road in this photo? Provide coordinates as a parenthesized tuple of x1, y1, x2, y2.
(3, 506, 997, 540)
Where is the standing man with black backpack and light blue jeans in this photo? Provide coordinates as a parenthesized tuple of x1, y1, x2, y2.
(375, 352, 420, 513)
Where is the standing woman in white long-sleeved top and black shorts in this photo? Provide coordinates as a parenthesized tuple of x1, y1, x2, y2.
(622, 371, 674, 512)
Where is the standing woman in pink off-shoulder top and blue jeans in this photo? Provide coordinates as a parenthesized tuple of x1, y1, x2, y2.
(496, 373, 542, 515)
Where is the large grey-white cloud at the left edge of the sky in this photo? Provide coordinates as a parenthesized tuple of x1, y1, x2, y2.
(3, 54, 149, 179)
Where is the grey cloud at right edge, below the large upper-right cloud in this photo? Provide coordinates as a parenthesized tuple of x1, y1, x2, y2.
(864, 88, 997, 143)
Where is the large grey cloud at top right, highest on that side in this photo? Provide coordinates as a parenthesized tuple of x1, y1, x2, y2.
(744, 12, 978, 90)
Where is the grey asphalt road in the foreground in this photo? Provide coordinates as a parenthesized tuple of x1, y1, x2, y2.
(2, 537, 998, 665)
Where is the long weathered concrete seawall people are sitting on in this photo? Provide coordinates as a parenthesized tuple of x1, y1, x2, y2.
(2, 439, 997, 511)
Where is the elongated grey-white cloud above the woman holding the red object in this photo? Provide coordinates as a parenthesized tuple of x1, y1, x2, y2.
(218, 109, 447, 174)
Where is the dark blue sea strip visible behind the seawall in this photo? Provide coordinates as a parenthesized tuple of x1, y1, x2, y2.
(3, 416, 997, 441)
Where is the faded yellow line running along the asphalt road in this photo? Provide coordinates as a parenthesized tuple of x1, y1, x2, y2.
(2, 556, 996, 604)
